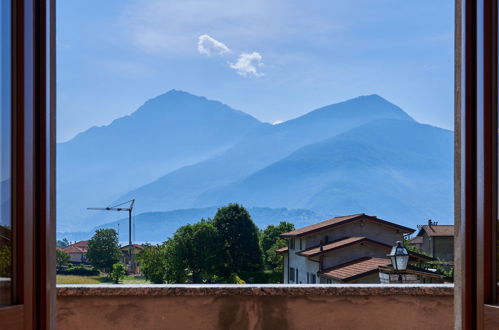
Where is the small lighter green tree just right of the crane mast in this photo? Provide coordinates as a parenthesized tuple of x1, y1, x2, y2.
(138, 245, 166, 284)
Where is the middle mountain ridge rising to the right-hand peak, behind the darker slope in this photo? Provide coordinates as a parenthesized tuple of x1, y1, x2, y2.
(119, 95, 414, 212)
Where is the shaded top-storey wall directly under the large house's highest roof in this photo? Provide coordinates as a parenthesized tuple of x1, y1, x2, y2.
(305, 220, 403, 248)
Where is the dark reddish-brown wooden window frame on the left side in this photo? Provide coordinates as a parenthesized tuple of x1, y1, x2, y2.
(0, 0, 56, 330)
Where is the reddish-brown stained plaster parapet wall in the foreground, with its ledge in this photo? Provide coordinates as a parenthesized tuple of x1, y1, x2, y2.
(57, 285, 453, 330)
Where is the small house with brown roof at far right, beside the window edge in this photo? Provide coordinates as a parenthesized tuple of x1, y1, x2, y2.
(411, 219, 454, 263)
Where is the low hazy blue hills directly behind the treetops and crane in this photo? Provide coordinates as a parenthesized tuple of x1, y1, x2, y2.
(57, 207, 330, 243)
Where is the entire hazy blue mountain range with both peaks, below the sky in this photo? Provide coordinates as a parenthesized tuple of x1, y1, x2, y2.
(58, 91, 453, 241)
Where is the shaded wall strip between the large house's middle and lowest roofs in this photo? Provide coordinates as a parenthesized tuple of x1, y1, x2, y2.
(324, 243, 390, 268)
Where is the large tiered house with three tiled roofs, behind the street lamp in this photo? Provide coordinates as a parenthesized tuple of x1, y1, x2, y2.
(277, 213, 414, 284)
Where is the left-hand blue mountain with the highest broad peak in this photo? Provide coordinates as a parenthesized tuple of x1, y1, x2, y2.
(57, 90, 264, 230)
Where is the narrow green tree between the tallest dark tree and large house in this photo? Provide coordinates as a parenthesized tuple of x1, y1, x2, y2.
(260, 221, 295, 271)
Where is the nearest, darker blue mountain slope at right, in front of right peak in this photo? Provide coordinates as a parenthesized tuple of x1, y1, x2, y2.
(195, 120, 453, 226)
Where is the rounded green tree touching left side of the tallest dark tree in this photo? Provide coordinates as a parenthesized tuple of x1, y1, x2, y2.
(166, 219, 224, 283)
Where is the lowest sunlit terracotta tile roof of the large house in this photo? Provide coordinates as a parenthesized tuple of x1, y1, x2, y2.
(319, 257, 391, 282)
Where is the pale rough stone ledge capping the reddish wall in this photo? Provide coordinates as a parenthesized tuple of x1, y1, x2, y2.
(57, 284, 454, 297)
